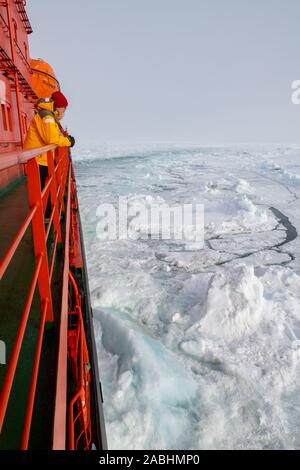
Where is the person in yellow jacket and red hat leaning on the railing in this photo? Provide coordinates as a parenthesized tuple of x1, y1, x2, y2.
(24, 91, 75, 218)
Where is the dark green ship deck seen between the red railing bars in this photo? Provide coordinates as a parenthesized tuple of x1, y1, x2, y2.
(0, 178, 62, 449)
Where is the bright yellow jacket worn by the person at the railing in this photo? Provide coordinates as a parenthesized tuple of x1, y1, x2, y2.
(24, 98, 71, 166)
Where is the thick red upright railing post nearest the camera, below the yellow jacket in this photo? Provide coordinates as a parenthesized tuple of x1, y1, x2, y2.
(27, 158, 54, 322)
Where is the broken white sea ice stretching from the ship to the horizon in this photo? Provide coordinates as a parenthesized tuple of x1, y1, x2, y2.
(74, 144, 300, 449)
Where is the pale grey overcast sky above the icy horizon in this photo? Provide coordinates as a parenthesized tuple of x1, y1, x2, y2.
(27, 0, 300, 144)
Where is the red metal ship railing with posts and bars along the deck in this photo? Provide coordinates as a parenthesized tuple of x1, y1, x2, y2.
(0, 146, 71, 449)
